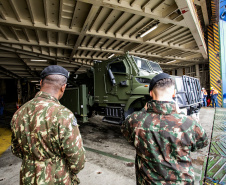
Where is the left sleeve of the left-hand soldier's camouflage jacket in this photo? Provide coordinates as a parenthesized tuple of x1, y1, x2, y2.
(11, 117, 23, 159)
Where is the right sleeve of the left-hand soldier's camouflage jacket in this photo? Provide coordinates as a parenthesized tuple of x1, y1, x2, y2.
(58, 109, 85, 184)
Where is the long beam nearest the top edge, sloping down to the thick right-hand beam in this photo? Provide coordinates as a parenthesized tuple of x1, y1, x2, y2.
(78, 0, 187, 27)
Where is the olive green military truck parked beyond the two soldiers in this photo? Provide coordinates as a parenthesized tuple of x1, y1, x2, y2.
(61, 53, 202, 124)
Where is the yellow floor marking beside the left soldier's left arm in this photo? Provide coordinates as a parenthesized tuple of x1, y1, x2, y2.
(0, 128, 12, 156)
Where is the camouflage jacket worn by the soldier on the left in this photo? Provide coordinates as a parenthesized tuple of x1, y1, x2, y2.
(11, 91, 85, 185)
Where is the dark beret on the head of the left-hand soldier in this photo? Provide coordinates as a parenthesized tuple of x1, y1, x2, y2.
(40, 65, 69, 79)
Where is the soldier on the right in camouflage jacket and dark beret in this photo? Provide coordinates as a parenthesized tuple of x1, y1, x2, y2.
(121, 73, 208, 185)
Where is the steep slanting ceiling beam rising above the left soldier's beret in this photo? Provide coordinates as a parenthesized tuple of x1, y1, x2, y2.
(69, 5, 99, 61)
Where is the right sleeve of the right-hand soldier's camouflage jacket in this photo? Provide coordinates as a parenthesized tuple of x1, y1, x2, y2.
(191, 121, 208, 152)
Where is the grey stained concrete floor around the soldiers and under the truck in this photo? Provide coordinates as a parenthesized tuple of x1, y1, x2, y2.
(0, 108, 214, 185)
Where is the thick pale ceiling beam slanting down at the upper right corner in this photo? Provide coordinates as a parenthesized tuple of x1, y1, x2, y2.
(175, 0, 208, 59)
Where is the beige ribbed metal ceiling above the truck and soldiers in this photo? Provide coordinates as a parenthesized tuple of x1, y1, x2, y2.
(0, 0, 208, 79)
